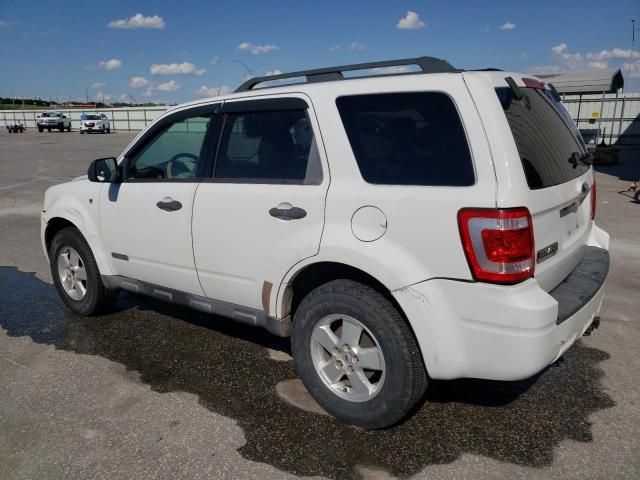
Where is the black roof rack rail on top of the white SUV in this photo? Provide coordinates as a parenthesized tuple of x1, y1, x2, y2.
(236, 57, 462, 92)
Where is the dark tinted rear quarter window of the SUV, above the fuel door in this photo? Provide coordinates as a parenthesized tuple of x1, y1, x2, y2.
(336, 92, 475, 187)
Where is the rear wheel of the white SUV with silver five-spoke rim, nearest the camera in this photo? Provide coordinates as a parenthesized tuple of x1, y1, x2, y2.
(291, 280, 427, 429)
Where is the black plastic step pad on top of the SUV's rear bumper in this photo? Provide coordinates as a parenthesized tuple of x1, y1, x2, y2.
(549, 247, 609, 325)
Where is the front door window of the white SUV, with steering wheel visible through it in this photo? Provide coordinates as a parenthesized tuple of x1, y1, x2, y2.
(127, 115, 212, 180)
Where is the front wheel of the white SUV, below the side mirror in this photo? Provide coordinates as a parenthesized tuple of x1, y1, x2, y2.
(49, 227, 118, 315)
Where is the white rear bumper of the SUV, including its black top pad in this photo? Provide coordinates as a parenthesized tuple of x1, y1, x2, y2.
(393, 227, 609, 380)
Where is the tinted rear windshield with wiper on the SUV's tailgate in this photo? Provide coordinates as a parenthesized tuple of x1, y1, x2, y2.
(496, 87, 589, 190)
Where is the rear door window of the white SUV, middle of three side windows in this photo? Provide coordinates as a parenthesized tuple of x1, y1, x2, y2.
(214, 110, 322, 185)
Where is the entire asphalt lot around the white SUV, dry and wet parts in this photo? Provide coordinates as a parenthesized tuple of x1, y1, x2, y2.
(0, 130, 640, 479)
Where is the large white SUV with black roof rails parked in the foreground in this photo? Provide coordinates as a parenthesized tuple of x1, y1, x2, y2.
(42, 57, 609, 428)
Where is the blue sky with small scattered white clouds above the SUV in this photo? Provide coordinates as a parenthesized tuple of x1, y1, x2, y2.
(0, 0, 640, 103)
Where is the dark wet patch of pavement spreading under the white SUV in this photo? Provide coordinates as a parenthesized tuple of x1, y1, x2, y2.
(0, 267, 614, 478)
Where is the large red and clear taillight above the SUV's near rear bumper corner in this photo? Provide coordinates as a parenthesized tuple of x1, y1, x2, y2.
(458, 208, 535, 283)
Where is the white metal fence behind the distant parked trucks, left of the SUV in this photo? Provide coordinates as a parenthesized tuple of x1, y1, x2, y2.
(0, 107, 169, 132)
